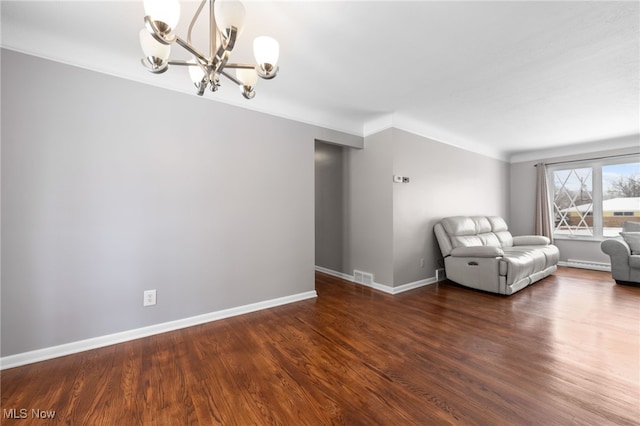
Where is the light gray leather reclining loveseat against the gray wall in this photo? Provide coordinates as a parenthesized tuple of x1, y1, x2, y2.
(434, 216, 560, 295)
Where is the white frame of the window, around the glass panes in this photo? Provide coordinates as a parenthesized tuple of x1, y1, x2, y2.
(546, 154, 640, 241)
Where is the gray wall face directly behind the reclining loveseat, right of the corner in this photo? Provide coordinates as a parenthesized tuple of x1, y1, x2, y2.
(388, 129, 509, 286)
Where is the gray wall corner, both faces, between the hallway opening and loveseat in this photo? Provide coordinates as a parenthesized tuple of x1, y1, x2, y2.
(341, 129, 509, 287)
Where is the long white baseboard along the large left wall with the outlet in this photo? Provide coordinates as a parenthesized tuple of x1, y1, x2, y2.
(0, 290, 318, 370)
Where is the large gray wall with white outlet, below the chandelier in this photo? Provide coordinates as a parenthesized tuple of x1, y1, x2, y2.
(1, 50, 361, 356)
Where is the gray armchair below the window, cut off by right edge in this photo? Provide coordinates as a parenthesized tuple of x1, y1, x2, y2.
(600, 222, 640, 284)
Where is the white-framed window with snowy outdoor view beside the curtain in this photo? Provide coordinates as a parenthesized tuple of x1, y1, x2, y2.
(547, 156, 640, 239)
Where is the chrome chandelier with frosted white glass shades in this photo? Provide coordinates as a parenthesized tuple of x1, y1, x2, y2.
(140, 0, 280, 99)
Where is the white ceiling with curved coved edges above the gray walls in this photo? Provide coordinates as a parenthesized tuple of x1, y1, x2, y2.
(1, 0, 640, 159)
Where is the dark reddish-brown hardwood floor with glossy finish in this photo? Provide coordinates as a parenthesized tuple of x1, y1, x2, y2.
(0, 268, 640, 425)
